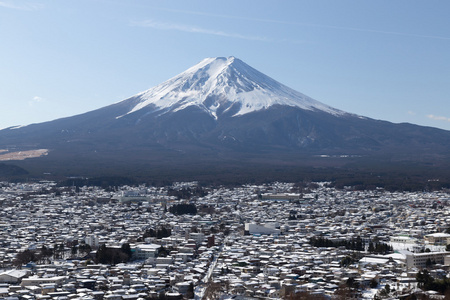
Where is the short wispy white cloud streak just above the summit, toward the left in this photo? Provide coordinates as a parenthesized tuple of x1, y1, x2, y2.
(131, 20, 272, 42)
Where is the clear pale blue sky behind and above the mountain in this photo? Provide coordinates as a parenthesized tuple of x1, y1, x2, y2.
(0, 0, 450, 130)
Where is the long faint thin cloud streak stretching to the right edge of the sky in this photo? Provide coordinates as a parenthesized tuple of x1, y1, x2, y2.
(155, 8, 450, 40)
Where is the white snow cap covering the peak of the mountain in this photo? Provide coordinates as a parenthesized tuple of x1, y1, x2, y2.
(123, 56, 345, 119)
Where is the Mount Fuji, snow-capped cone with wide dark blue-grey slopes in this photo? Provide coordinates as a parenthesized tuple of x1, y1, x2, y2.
(0, 57, 450, 180)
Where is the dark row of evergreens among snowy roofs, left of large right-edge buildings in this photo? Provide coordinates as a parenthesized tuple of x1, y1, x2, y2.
(309, 236, 394, 254)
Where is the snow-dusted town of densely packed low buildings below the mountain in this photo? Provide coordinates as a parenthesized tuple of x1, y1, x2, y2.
(0, 181, 450, 300)
